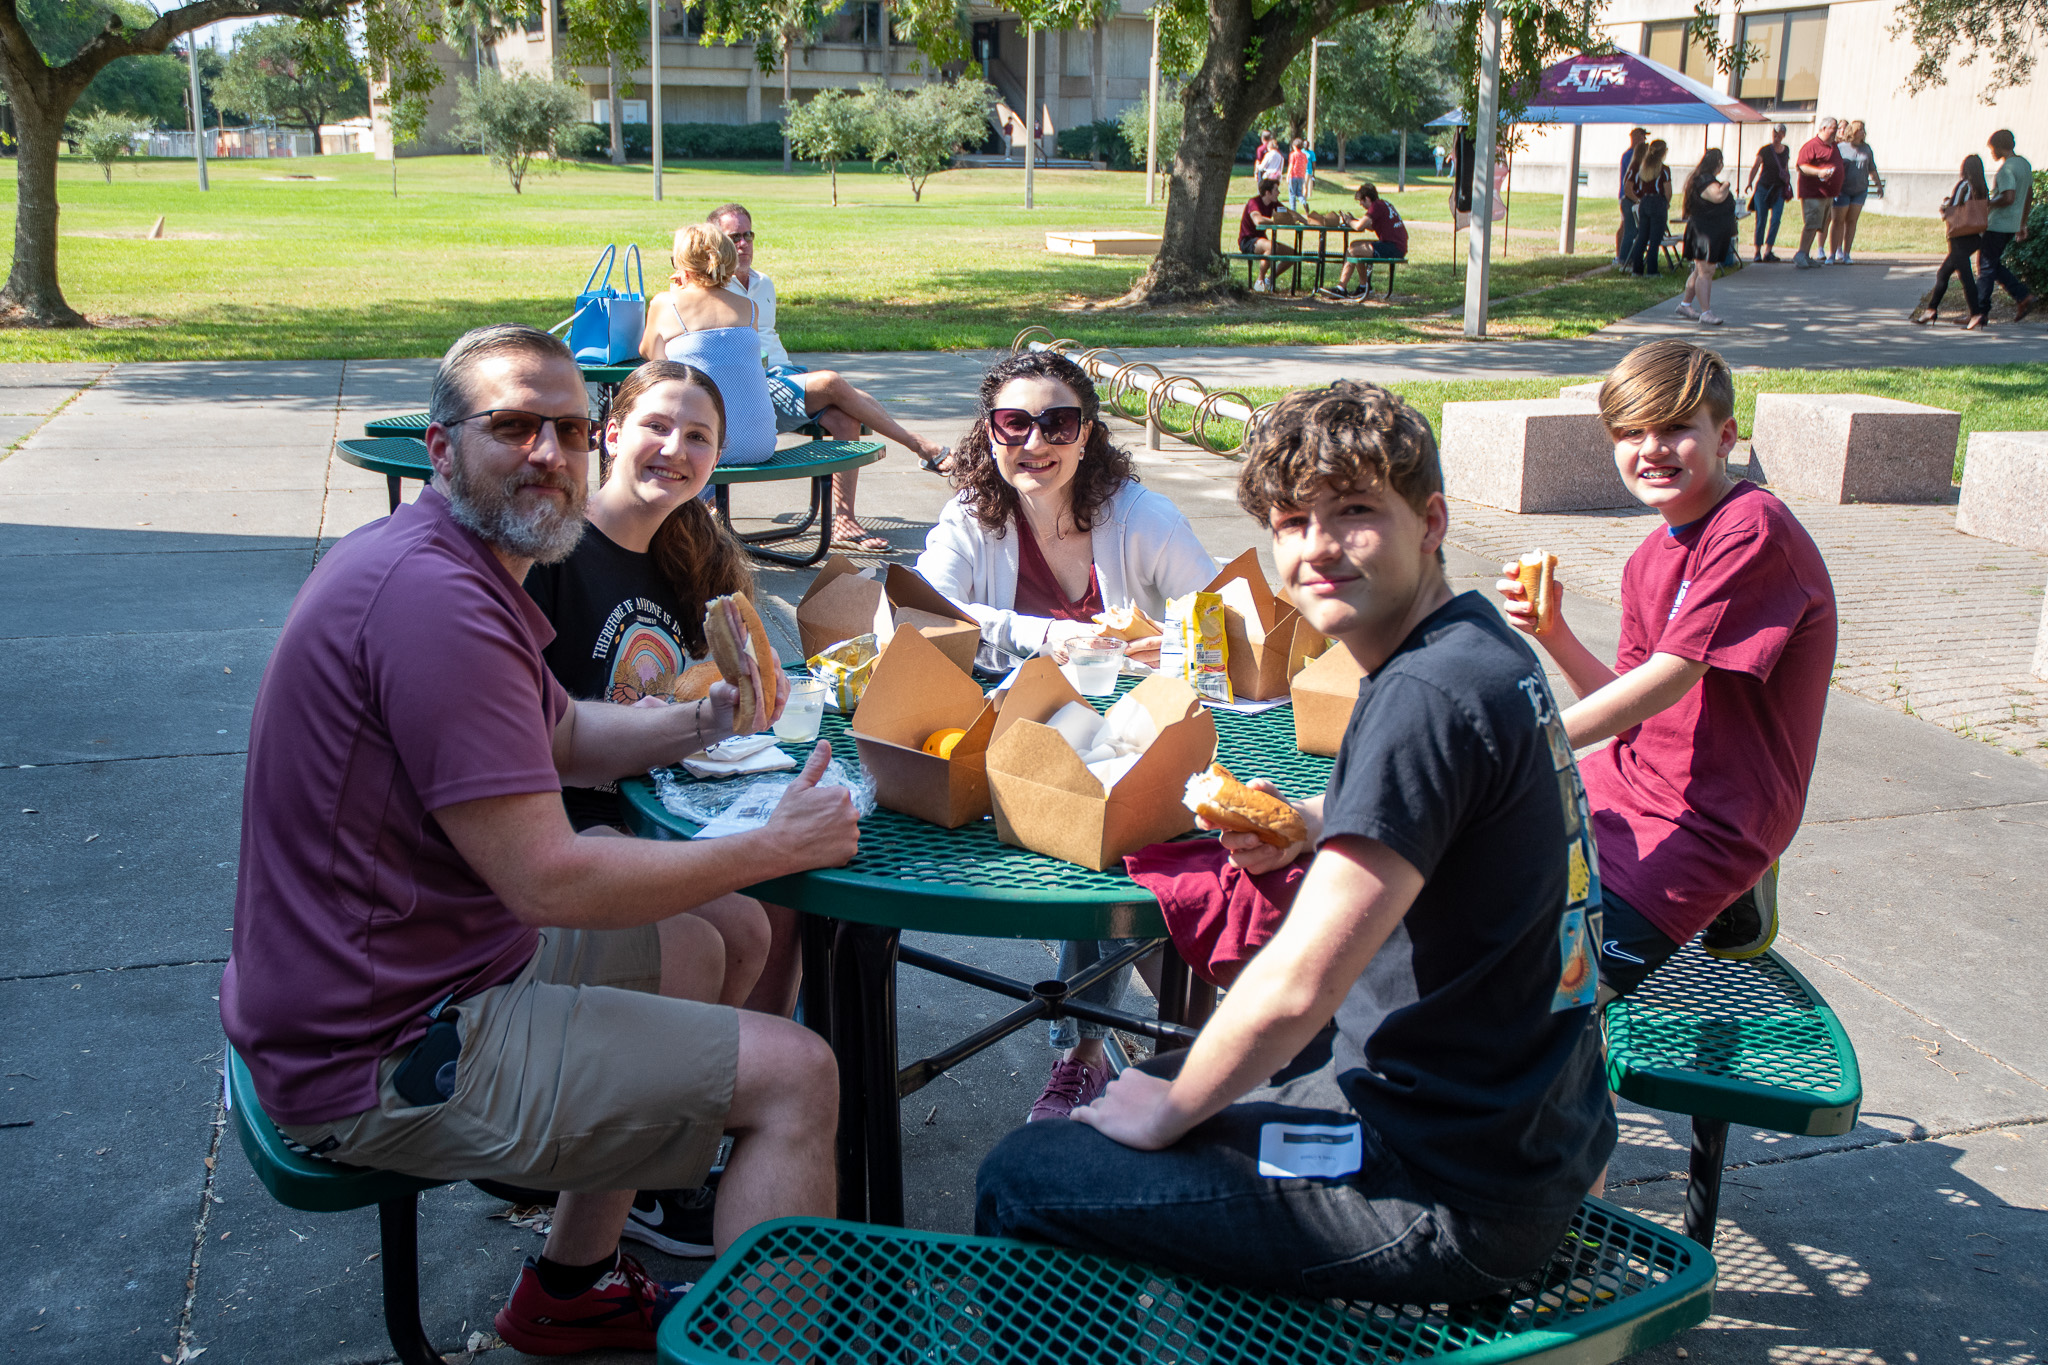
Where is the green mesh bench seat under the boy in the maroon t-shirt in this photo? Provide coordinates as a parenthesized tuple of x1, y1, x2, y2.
(1602, 943, 1864, 1246)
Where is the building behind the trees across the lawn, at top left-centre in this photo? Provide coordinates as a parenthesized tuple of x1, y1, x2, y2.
(377, 0, 1151, 158)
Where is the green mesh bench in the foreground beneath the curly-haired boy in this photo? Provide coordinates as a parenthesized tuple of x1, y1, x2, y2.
(657, 1199, 1714, 1365)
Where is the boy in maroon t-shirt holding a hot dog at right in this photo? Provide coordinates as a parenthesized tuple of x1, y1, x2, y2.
(1499, 340, 1835, 1001)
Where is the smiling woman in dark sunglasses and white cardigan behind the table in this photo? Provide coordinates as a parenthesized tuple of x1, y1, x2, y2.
(918, 352, 1217, 1121)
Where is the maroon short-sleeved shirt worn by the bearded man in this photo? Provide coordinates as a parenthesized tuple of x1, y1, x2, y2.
(221, 487, 569, 1124)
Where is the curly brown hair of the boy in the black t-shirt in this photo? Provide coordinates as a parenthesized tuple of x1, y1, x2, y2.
(1237, 379, 1444, 524)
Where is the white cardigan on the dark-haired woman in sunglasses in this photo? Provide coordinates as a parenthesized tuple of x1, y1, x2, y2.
(918, 481, 1217, 655)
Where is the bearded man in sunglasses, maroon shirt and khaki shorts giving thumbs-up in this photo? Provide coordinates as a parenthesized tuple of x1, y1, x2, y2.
(219, 325, 858, 1355)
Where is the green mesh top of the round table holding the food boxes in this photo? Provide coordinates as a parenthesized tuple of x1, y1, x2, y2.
(618, 669, 1329, 939)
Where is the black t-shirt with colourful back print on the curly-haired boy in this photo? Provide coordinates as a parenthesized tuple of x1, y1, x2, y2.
(1323, 593, 1614, 1218)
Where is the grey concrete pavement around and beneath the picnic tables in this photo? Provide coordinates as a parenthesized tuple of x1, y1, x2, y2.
(0, 356, 2048, 1365)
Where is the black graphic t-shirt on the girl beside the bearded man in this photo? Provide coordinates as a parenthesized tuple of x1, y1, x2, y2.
(526, 526, 688, 829)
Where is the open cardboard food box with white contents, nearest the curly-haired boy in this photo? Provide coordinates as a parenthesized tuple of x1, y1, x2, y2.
(987, 659, 1217, 872)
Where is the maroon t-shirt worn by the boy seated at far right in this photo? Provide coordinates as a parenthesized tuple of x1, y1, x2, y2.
(1579, 479, 1835, 943)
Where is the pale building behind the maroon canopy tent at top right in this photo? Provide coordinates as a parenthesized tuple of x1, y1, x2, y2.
(1511, 0, 2048, 217)
